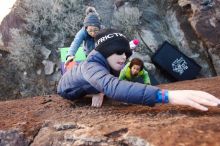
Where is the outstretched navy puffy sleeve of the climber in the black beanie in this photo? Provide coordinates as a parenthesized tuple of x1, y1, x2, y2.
(82, 62, 160, 106)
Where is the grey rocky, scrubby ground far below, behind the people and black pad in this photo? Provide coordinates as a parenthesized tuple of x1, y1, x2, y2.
(0, 0, 220, 99)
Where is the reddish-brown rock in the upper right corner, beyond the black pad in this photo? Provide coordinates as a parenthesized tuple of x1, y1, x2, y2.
(179, 0, 220, 75)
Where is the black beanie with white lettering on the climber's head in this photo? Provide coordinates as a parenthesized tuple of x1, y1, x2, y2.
(95, 29, 132, 58)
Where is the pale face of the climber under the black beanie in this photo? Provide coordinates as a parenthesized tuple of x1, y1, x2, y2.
(107, 53, 126, 71)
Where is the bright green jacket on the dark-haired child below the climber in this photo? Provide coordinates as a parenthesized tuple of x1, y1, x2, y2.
(119, 62, 151, 85)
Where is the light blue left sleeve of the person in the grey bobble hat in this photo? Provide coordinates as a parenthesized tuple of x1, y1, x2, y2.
(67, 28, 86, 56)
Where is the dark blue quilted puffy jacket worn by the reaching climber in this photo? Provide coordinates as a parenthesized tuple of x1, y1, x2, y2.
(57, 50, 159, 105)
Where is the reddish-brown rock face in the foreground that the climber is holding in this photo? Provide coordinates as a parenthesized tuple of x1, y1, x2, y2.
(0, 77, 220, 146)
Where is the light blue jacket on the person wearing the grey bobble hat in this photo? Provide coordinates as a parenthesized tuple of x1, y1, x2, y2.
(67, 27, 95, 56)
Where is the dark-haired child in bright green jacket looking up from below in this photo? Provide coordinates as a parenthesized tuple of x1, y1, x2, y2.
(119, 58, 151, 85)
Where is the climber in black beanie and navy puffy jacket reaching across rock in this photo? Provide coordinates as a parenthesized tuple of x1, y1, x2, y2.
(57, 29, 220, 111)
